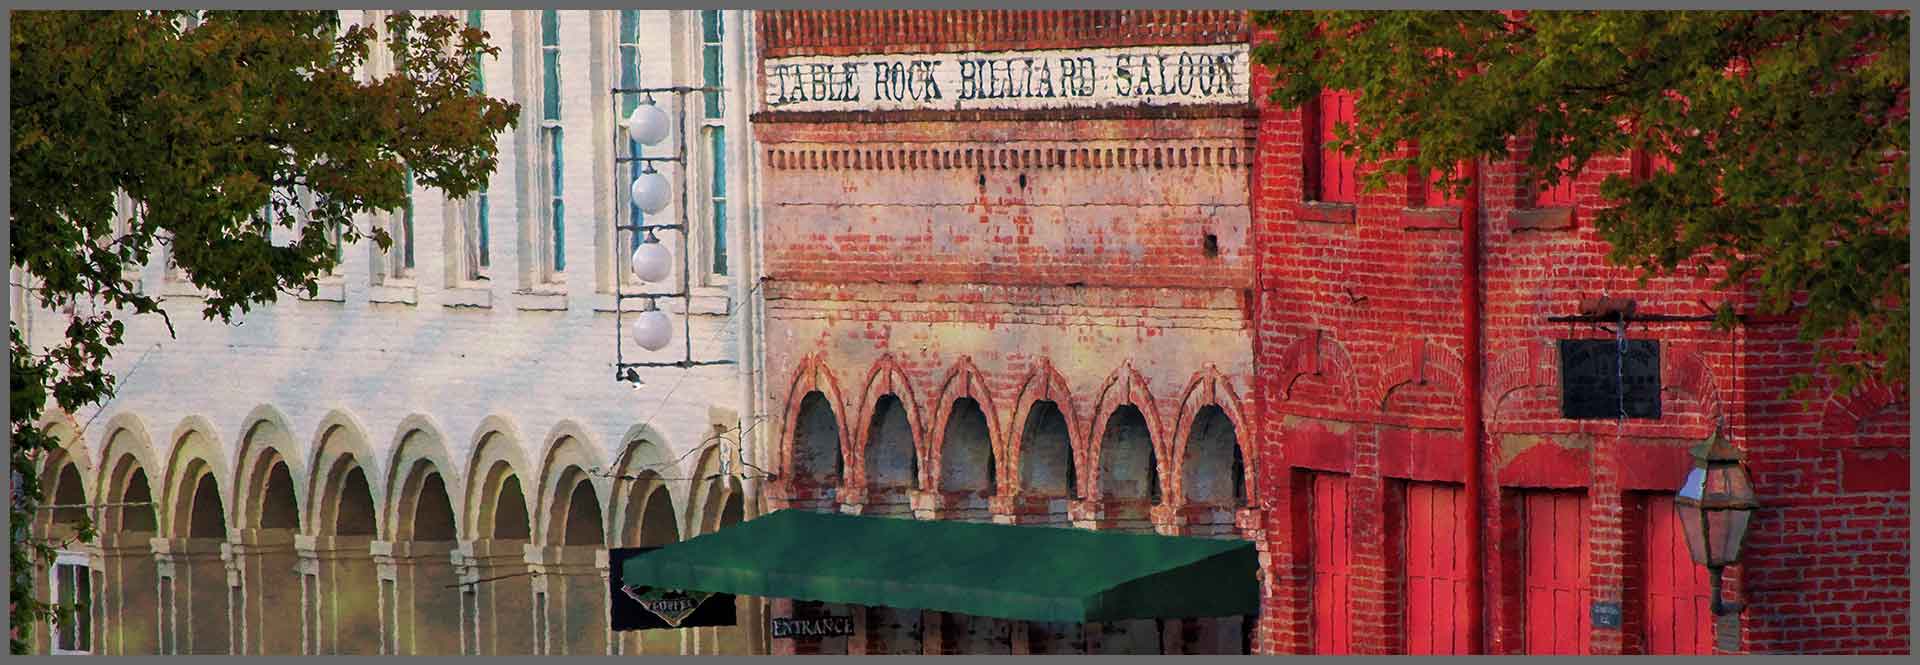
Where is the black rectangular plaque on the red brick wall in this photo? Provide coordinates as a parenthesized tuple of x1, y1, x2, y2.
(1559, 340, 1661, 419)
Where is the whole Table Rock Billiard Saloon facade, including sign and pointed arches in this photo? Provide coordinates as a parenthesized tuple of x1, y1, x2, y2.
(753, 12, 1254, 653)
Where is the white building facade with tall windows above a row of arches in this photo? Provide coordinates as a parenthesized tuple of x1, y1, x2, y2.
(15, 10, 766, 653)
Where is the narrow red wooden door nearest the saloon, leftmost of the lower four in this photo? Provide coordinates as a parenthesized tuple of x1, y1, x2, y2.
(1309, 473, 1354, 653)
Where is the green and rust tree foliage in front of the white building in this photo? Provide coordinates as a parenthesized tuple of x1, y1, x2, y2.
(8, 12, 520, 653)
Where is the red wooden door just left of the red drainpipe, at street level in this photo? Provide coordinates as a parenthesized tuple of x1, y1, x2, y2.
(1400, 482, 1469, 655)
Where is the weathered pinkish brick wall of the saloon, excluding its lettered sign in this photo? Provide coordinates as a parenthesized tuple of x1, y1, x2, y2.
(755, 12, 1254, 653)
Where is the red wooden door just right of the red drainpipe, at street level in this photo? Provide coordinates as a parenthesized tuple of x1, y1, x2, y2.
(1521, 492, 1592, 655)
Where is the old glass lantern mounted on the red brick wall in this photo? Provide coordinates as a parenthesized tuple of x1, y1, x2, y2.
(1674, 431, 1761, 571)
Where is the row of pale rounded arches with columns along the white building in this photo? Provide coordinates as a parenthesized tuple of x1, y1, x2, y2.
(36, 407, 749, 653)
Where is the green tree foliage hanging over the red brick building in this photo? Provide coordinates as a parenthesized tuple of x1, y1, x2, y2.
(1254, 12, 1910, 390)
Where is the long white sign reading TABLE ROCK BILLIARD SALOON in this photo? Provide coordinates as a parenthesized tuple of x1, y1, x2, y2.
(764, 44, 1250, 111)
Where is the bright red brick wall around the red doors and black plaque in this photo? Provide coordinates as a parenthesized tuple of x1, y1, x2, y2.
(1252, 49, 1910, 653)
